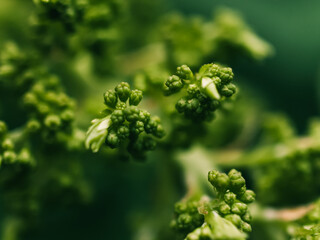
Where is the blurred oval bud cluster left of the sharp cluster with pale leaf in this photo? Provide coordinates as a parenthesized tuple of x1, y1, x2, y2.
(23, 76, 74, 142)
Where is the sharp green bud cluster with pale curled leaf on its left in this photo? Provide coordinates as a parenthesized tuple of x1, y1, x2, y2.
(86, 82, 164, 159)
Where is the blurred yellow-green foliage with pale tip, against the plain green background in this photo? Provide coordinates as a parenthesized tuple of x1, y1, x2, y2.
(159, 8, 274, 67)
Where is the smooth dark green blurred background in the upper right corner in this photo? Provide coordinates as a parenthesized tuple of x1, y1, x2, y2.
(170, 0, 320, 131)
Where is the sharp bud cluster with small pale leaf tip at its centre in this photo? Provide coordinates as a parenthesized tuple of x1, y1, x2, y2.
(164, 64, 236, 121)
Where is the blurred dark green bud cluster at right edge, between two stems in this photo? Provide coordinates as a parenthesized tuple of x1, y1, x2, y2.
(256, 148, 320, 205)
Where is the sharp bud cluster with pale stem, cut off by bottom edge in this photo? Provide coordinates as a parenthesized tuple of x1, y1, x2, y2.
(171, 169, 255, 240)
